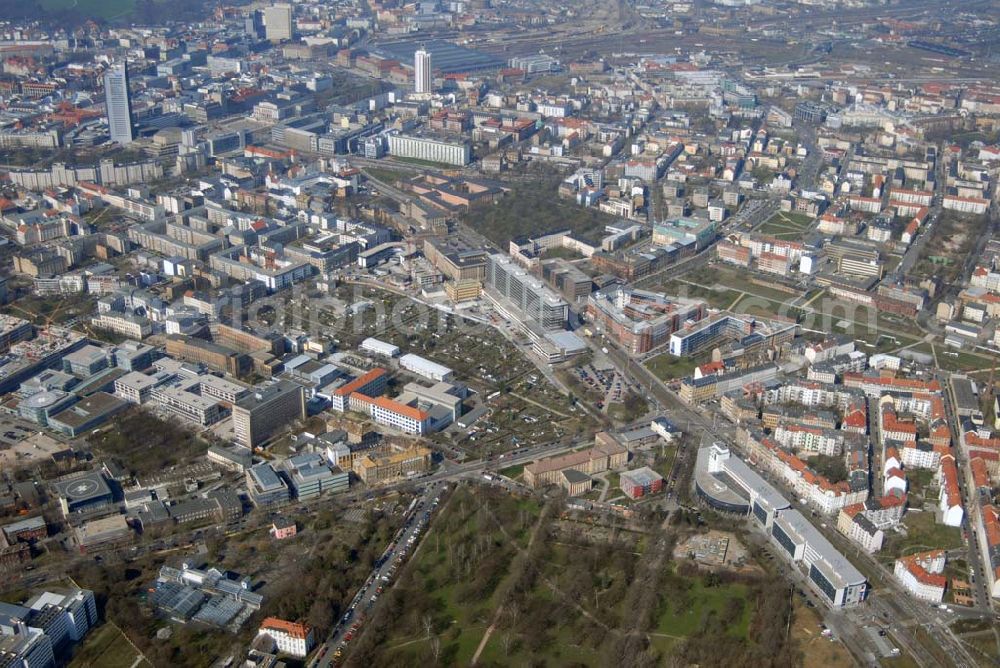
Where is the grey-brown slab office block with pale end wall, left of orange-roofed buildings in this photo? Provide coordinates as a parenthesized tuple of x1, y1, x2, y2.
(233, 380, 306, 448)
